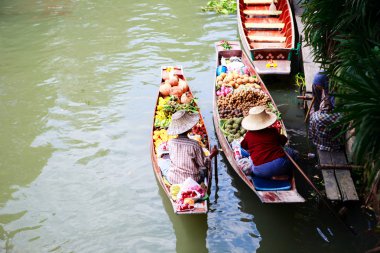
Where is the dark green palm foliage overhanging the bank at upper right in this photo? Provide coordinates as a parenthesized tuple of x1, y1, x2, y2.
(302, 0, 380, 186)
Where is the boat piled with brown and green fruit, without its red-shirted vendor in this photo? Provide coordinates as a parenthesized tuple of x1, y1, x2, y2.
(213, 41, 305, 203)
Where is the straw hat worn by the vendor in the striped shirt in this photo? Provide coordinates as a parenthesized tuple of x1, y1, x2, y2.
(167, 110, 199, 135)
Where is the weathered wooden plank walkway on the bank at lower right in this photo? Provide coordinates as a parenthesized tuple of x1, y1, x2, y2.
(317, 150, 359, 201)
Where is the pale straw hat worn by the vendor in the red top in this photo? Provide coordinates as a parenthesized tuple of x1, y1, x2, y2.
(241, 106, 277, 131)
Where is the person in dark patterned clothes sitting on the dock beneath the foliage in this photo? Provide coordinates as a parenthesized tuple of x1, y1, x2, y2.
(309, 96, 343, 151)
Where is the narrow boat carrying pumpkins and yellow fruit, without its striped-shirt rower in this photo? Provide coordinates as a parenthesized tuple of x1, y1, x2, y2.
(151, 66, 212, 214)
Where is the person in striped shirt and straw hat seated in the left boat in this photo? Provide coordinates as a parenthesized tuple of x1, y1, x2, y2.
(162, 110, 218, 184)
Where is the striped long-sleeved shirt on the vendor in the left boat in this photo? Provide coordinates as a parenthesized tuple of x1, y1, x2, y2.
(167, 135, 210, 184)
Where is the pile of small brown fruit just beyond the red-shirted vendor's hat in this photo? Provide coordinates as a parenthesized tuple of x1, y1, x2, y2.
(217, 89, 270, 119)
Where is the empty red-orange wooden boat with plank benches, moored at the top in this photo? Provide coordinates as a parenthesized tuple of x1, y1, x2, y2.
(237, 0, 299, 75)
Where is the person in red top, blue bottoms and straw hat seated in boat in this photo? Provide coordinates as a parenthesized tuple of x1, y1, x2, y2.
(241, 106, 296, 179)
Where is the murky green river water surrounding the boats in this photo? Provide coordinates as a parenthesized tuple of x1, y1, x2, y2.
(0, 0, 375, 253)
